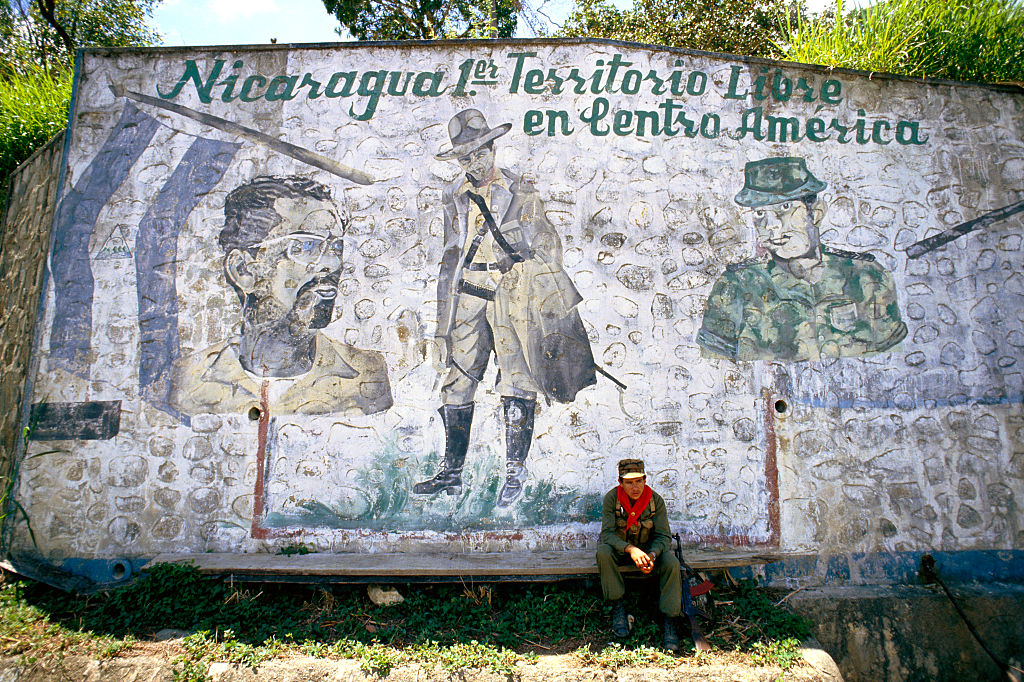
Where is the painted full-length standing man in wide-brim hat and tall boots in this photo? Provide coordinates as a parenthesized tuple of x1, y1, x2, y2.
(413, 109, 595, 507)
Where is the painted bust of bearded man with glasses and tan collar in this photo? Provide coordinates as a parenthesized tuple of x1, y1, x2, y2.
(171, 176, 391, 415)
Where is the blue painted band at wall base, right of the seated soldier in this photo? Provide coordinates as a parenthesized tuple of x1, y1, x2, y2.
(729, 550, 1024, 587)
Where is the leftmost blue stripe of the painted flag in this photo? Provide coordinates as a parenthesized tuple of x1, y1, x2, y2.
(50, 102, 160, 376)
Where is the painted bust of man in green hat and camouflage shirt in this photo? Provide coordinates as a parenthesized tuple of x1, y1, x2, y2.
(697, 157, 906, 361)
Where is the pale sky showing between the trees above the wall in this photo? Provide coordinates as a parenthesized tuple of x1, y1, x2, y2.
(153, 0, 830, 46)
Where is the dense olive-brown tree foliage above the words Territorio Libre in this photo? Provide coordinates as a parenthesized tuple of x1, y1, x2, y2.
(556, 0, 801, 57)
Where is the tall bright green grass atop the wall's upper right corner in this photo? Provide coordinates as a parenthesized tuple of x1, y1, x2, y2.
(778, 0, 1024, 82)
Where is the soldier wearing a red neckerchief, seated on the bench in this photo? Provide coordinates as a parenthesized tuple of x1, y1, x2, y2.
(597, 460, 683, 651)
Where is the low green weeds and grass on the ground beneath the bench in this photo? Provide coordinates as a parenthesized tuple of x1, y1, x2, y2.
(0, 564, 810, 682)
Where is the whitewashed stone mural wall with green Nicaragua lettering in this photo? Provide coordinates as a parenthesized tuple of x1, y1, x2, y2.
(13, 42, 1024, 581)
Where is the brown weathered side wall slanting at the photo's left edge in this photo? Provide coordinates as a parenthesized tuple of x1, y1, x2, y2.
(0, 133, 65, 483)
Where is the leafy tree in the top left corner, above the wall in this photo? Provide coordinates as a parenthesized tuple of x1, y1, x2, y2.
(0, 0, 160, 78)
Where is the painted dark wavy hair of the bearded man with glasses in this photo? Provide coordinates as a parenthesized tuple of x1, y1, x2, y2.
(217, 175, 331, 253)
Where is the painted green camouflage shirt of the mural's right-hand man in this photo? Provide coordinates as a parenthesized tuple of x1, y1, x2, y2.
(697, 246, 906, 361)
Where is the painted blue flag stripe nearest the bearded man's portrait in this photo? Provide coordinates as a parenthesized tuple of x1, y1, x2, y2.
(135, 137, 241, 423)
